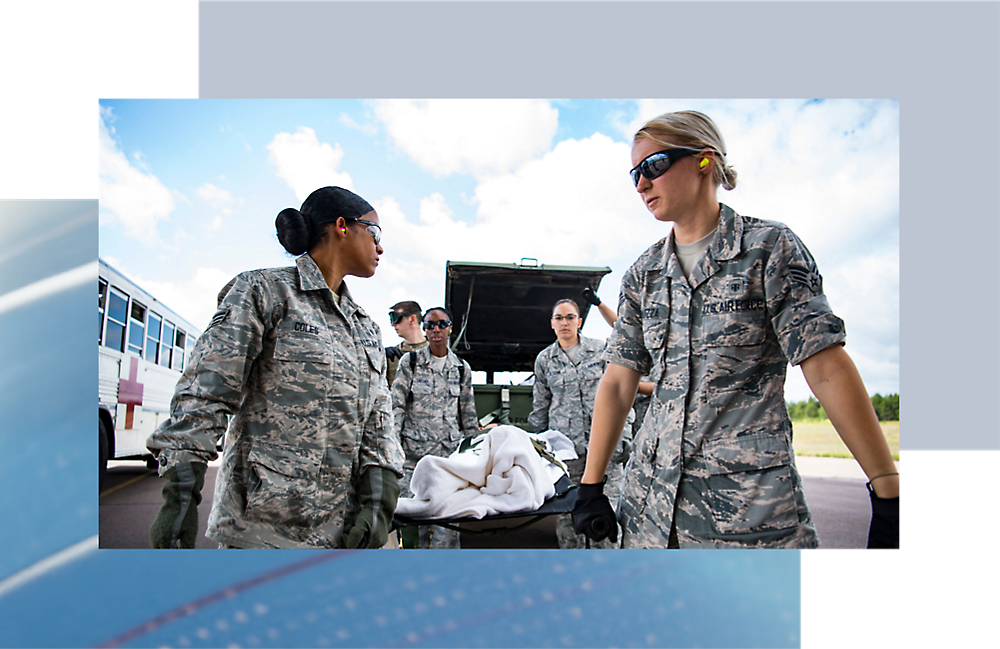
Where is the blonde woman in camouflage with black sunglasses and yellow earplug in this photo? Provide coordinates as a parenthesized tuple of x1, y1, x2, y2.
(573, 111, 899, 549)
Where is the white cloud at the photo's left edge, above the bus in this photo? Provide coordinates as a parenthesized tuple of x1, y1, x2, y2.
(97, 107, 174, 246)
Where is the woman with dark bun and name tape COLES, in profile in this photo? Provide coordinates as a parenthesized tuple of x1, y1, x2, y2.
(146, 187, 403, 548)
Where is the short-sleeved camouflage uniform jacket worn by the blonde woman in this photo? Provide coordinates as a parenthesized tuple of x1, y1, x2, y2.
(606, 205, 845, 549)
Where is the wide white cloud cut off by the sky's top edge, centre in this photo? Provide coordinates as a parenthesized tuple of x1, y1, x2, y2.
(374, 99, 559, 177)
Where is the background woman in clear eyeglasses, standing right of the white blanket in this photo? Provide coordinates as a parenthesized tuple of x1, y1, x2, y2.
(528, 299, 631, 548)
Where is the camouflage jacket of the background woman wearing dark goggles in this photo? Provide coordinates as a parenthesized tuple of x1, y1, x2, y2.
(392, 347, 479, 468)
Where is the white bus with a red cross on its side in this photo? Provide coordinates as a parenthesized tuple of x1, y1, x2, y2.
(97, 259, 201, 489)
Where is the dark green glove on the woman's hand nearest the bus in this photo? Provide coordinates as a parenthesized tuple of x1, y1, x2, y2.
(149, 462, 208, 549)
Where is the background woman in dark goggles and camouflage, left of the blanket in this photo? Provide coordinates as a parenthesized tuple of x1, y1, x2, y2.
(392, 307, 479, 549)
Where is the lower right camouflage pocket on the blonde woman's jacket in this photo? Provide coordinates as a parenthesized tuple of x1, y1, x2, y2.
(704, 435, 799, 535)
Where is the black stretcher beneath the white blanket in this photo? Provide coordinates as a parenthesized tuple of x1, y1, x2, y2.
(392, 475, 576, 548)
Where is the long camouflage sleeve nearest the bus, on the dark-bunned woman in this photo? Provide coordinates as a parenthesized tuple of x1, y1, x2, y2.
(146, 273, 273, 475)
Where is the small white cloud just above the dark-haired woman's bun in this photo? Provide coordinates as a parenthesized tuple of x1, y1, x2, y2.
(267, 126, 354, 202)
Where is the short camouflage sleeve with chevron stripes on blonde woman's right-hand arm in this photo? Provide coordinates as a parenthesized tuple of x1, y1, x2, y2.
(764, 228, 846, 365)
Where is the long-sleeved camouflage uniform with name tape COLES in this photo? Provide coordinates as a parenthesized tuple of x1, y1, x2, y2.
(146, 254, 403, 548)
